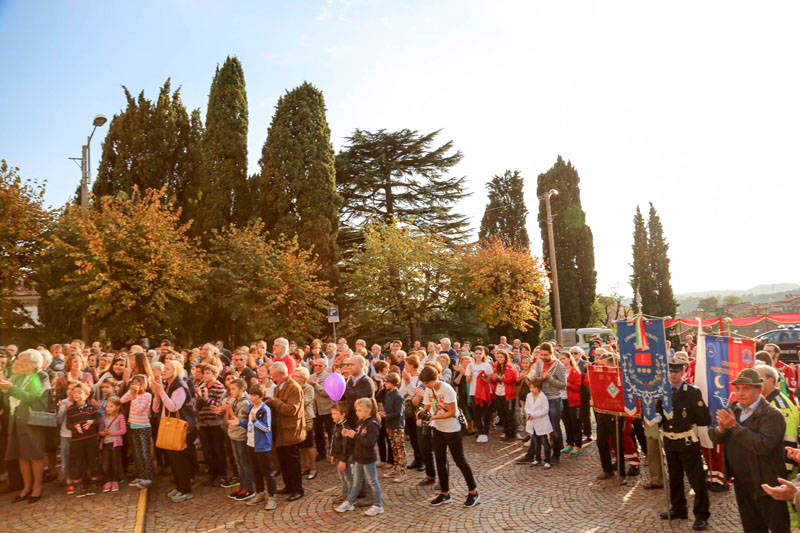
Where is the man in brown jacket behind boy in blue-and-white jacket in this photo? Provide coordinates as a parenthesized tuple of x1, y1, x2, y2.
(264, 361, 306, 502)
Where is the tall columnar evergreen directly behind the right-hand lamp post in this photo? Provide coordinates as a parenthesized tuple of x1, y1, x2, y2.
(536, 156, 597, 328)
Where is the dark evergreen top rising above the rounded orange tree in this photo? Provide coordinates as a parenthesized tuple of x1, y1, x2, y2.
(478, 170, 530, 250)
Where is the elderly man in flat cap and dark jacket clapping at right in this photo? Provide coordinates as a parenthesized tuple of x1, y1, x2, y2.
(709, 368, 789, 532)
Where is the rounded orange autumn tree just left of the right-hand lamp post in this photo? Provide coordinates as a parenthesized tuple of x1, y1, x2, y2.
(457, 236, 547, 336)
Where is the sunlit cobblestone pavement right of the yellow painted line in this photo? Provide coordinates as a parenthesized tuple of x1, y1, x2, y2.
(145, 432, 741, 533)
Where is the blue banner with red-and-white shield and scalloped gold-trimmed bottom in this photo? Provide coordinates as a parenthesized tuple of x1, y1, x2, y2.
(617, 317, 672, 423)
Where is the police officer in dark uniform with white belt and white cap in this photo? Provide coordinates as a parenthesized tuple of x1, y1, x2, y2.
(659, 356, 711, 531)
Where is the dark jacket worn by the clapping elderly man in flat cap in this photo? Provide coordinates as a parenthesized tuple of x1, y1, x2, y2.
(708, 398, 786, 498)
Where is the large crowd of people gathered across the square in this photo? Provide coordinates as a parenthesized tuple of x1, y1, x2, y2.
(0, 337, 800, 531)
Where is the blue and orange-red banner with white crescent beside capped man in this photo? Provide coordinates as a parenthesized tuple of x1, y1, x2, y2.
(705, 335, 755, 418)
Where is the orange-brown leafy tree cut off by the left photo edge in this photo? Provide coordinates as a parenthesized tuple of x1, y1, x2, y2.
(0, 159, 53, 344)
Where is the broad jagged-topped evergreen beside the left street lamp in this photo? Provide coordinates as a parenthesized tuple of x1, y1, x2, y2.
(93, 79, 203, 209)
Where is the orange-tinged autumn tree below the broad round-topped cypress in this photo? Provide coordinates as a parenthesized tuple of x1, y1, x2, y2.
(207, 222, 331, 341)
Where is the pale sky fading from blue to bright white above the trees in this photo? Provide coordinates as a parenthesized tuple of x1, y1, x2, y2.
(0, 0, 800, 296)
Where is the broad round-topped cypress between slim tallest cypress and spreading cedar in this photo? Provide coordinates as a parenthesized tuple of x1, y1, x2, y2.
(256, 82, 341, 285)
